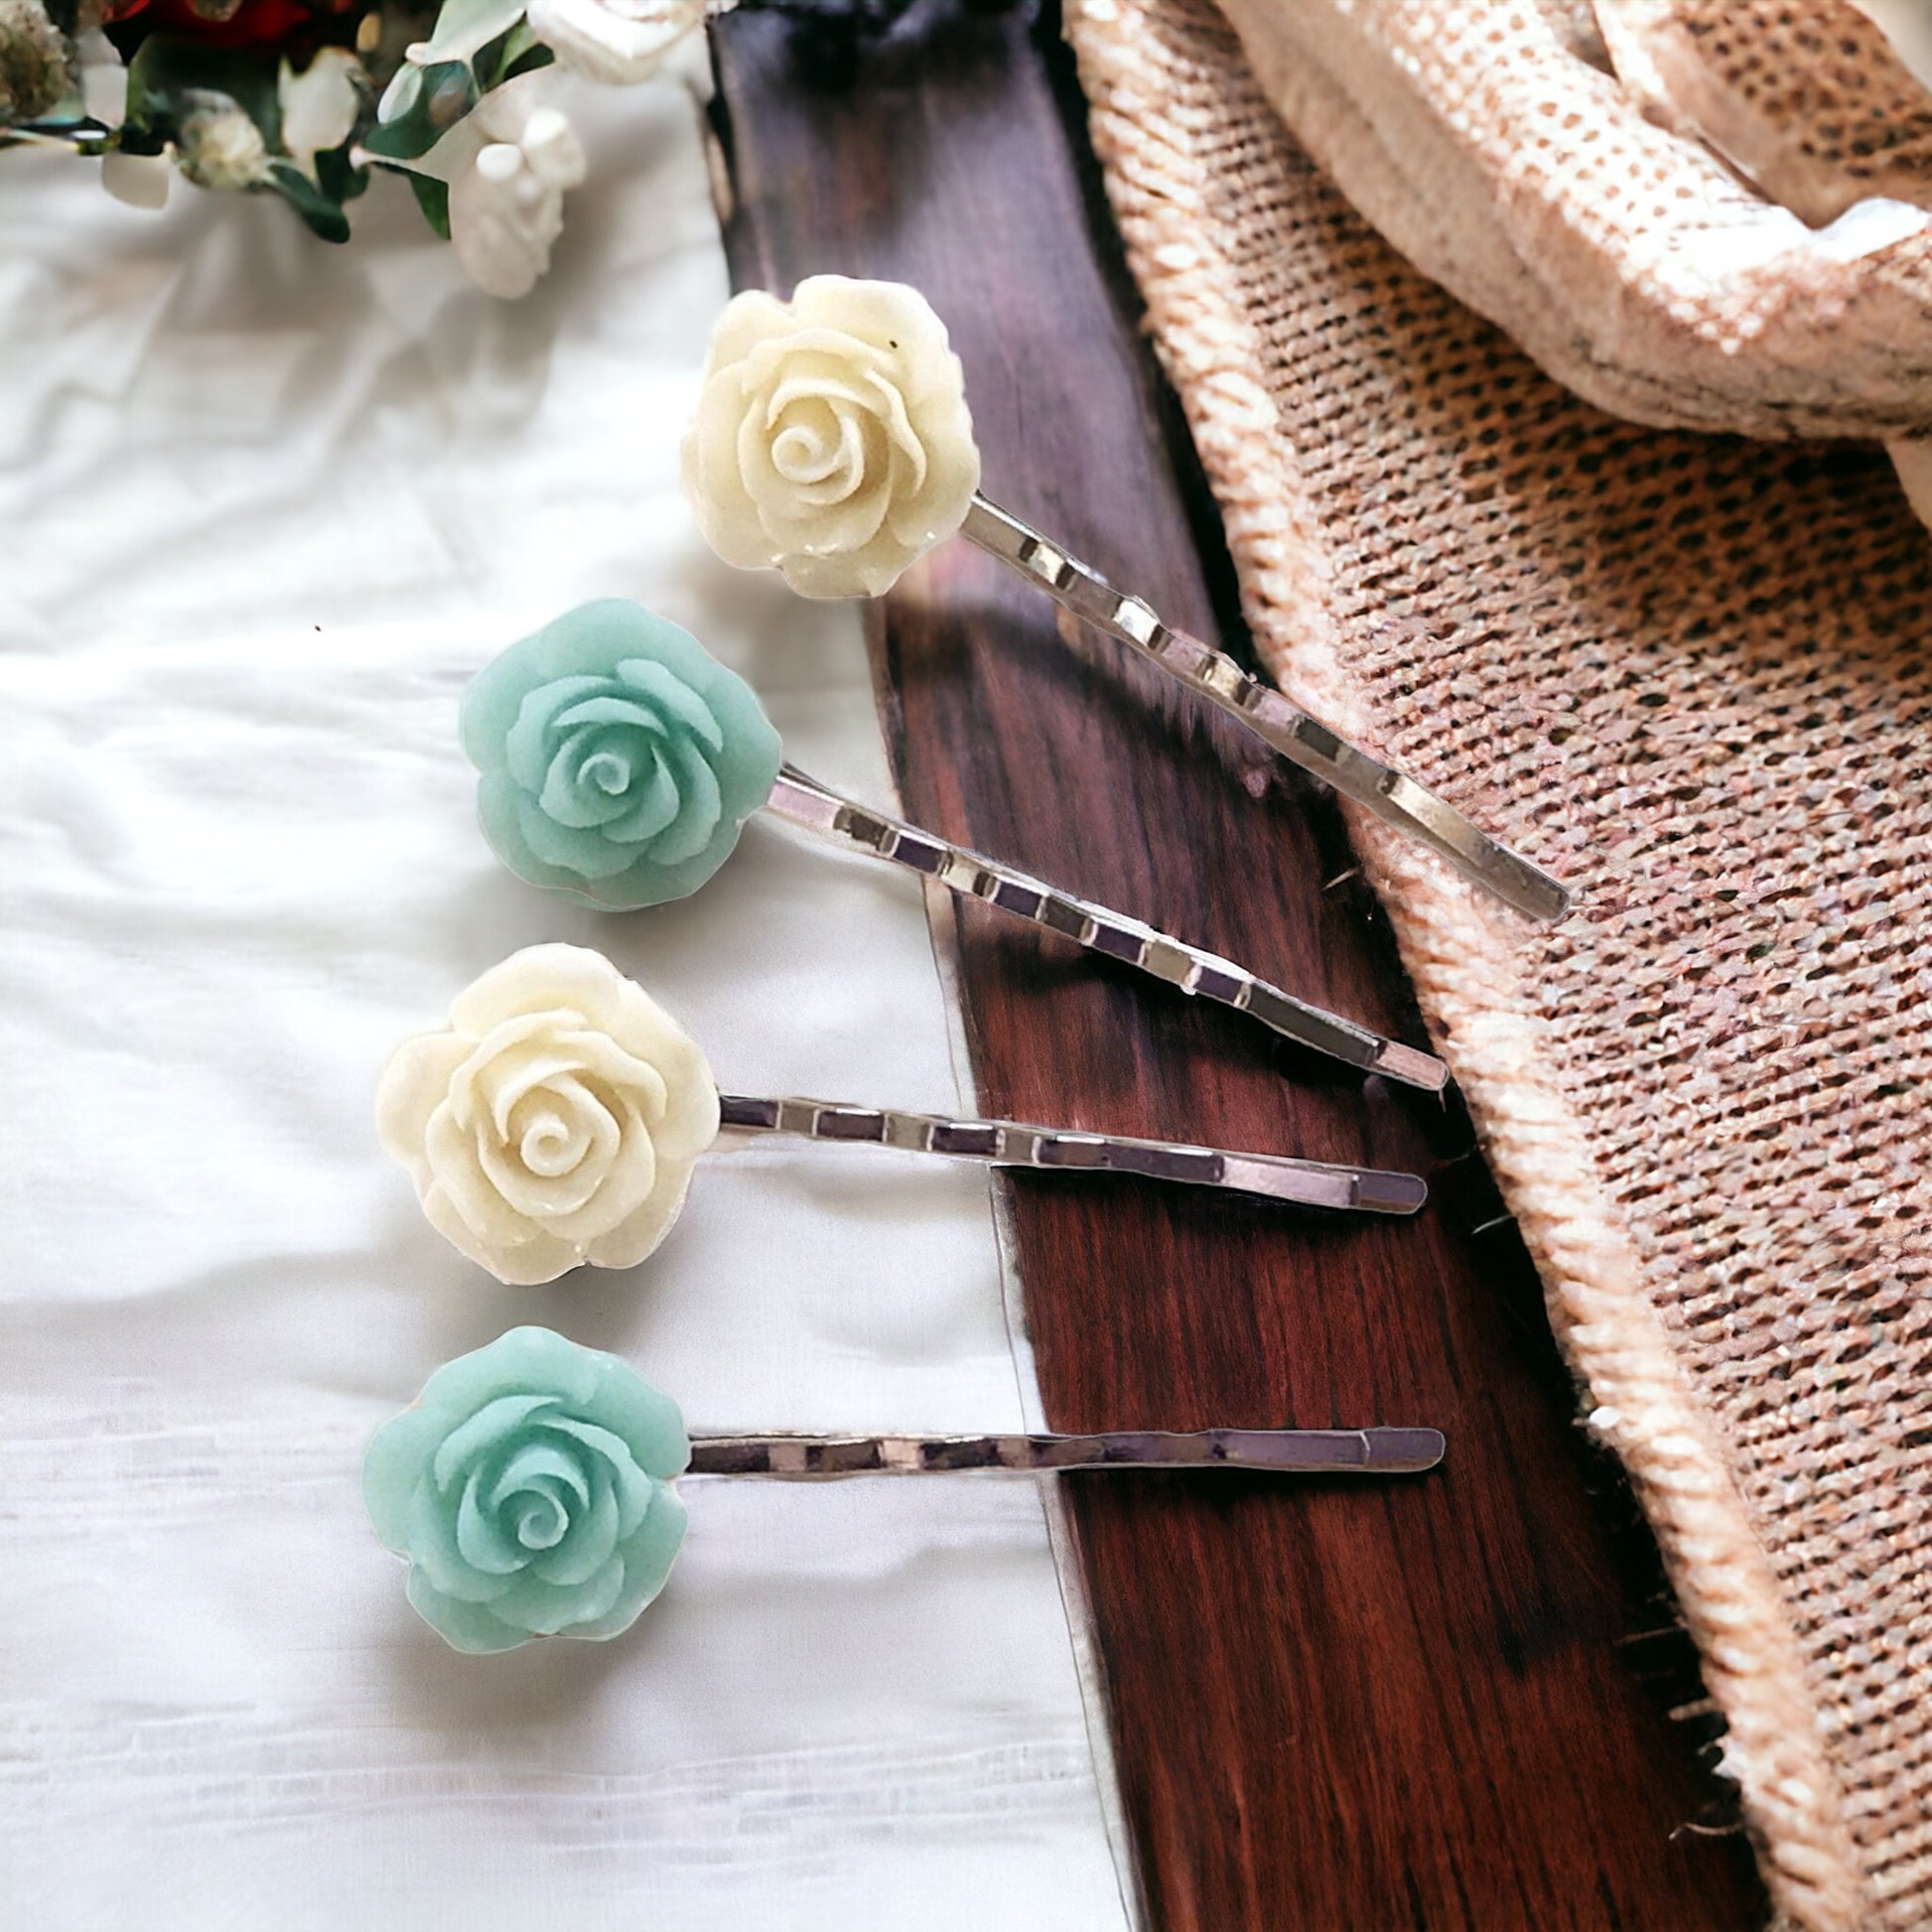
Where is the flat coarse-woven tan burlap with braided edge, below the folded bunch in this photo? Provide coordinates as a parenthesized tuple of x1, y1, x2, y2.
(1068, 0, 1932, 1928)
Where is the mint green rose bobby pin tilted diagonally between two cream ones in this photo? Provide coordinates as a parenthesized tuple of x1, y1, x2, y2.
(462, 599, 1449, 1091)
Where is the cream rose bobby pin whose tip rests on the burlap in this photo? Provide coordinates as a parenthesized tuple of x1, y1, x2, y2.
(684, 274, 1569, 919)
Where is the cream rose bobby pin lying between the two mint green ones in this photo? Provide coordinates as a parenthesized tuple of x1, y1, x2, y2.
(376, 945, 1428, 1285)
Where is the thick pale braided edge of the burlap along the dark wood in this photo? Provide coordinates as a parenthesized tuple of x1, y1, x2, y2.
(1066, 0, 1872, 1932)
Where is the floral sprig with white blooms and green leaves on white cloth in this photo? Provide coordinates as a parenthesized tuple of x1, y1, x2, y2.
(0, 0, 729, 298)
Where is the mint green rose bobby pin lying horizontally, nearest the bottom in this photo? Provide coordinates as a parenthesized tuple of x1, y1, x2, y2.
(363, 1327, 1444, 1656)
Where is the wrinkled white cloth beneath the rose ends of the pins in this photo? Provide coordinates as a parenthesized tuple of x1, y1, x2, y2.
(0, 60, 1125, 1932)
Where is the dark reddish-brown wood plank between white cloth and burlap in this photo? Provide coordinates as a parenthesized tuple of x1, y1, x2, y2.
(715, 12, 1766, 1932)
